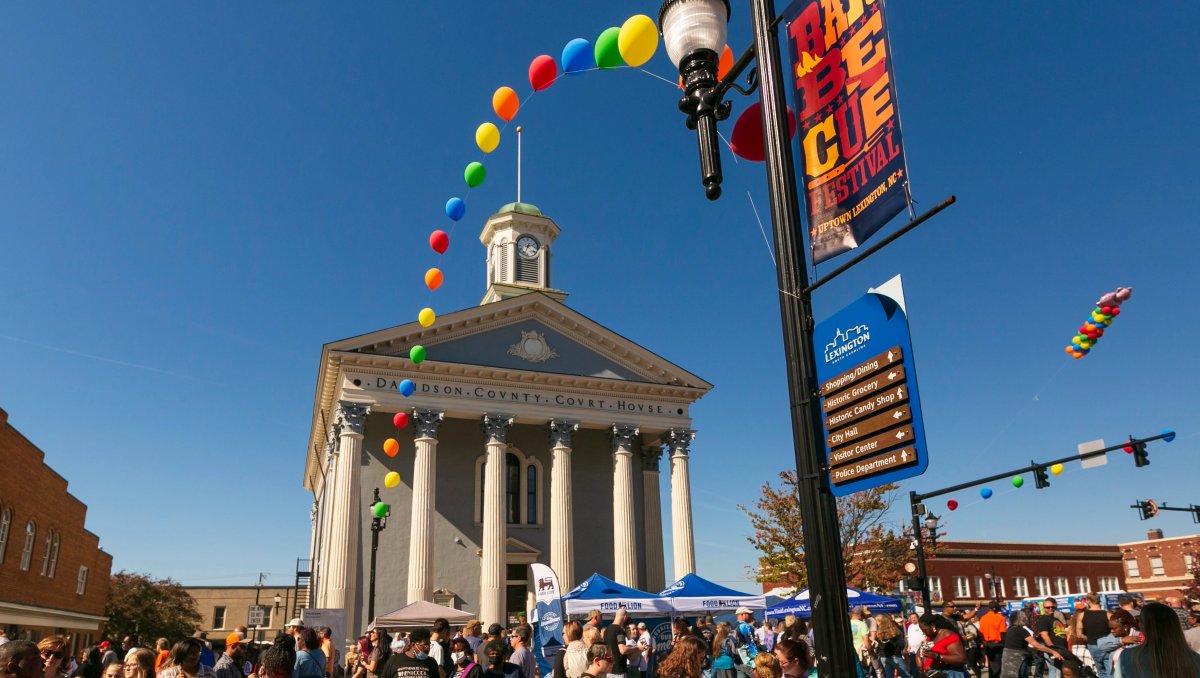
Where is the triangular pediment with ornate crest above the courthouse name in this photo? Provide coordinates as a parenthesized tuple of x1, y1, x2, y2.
(328, 293, 712, 390)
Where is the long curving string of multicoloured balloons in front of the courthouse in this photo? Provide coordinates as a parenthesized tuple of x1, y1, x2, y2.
(372, 14, 696, 496)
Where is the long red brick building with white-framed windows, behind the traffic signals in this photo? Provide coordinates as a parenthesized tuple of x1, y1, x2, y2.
(912, 541, 1124, 605)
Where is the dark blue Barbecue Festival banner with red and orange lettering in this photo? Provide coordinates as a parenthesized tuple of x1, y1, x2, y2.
(784, 0, 908, 265)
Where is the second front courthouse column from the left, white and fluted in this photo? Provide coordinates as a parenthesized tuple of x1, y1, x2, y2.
(408, 409, 444, 602)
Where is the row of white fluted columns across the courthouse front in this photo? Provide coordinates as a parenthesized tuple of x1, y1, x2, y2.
(316, 401, 696, 623)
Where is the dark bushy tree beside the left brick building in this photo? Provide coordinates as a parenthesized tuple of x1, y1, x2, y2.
(104, 570, 202, 647)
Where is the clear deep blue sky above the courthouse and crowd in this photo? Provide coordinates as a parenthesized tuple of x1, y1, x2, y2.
(0, 1, 1200, 586)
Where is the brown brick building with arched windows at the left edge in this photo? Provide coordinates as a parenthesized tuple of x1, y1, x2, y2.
(0, 409, 113, 650)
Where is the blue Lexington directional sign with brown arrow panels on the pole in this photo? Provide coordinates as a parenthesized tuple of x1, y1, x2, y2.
(812, 276, 929, 497)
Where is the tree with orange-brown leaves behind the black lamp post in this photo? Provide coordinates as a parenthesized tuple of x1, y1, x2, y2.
(738, 470, 913, 590)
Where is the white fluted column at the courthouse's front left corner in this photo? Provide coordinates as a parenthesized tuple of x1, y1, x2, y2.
(324, 401, 371, 614)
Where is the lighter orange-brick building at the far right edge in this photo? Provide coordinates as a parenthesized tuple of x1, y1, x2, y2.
(1117, 529, 1200, 600)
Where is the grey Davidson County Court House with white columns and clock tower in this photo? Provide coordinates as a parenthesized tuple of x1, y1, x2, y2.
(304, 203, 712, 634)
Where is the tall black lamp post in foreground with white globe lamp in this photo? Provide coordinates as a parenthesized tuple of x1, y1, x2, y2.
(659, 0, 857, 678)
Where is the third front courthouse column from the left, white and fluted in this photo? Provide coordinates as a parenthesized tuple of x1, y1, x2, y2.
(479, 414, 512, 626)
